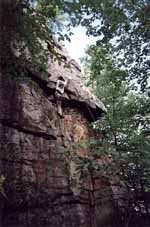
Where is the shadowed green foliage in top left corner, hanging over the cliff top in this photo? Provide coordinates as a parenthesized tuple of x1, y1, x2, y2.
(0, 0, 73, 70)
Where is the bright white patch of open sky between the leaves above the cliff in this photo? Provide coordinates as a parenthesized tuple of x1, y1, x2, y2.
(64, 26, 97, 64)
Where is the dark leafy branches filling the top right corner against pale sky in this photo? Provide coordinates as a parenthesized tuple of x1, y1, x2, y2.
(67, 0, 150, 91)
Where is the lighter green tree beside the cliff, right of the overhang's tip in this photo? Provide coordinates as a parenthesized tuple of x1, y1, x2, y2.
(81, 46, 150, 226)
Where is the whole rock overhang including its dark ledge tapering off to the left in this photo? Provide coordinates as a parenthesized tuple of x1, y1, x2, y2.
(17, 41, 107, 121)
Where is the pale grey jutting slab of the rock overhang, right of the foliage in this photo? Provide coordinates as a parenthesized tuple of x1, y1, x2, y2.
(48, 40, 106, 121)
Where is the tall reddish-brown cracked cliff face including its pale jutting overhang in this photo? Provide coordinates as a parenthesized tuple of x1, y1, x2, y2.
(0, 41, 112, 227)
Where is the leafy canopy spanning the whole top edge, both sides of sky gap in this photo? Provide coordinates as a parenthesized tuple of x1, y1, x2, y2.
(2, 0, 150, 91)
